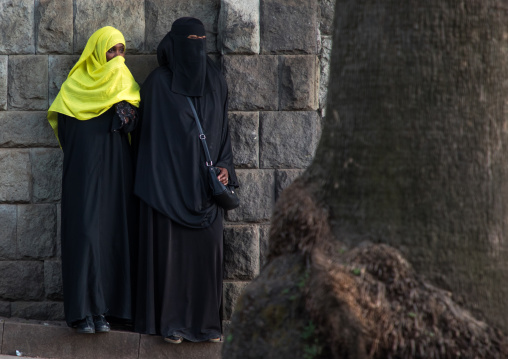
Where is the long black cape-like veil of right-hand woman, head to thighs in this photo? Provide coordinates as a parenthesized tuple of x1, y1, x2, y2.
(132, 18, 238, 228)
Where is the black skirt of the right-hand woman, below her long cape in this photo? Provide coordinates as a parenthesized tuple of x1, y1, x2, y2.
(136, 202, 223, 342)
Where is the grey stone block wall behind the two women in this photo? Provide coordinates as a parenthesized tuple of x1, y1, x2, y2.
(0, 0, 334, 320)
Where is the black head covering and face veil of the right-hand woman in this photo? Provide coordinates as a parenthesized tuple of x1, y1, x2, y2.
(157, 17, 206, 97)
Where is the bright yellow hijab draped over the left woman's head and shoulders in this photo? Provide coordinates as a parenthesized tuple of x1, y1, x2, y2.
(48, 26, 139, 143)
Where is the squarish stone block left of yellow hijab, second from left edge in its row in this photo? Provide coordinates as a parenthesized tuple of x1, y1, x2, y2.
(8, 55, 48, 110)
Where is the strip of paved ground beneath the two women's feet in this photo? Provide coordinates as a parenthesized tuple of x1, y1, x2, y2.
(0, 319, 222, 359)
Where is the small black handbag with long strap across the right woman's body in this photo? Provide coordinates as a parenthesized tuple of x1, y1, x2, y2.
(186, 96, 240, 210)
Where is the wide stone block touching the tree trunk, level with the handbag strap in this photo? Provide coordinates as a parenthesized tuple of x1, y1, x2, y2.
(259, 112, 321, 168)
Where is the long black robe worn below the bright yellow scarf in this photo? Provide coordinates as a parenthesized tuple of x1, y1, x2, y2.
(58, 108, 137, 325)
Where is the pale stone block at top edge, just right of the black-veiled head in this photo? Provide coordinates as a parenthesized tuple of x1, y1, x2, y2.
(219, 0, 260, 54)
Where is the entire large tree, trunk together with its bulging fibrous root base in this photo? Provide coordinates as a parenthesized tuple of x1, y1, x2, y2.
(223, 0, 508, 359)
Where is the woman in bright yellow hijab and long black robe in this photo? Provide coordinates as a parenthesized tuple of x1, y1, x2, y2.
(48, 26, 139, 333)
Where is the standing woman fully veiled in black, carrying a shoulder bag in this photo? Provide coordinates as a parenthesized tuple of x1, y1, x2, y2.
(133, 18, 238, 343)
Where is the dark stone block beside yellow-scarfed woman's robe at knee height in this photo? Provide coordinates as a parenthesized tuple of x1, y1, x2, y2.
(18, 204, 56, 259)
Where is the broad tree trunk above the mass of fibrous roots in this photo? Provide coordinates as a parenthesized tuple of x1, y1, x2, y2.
(304, 0, 508, 331)
